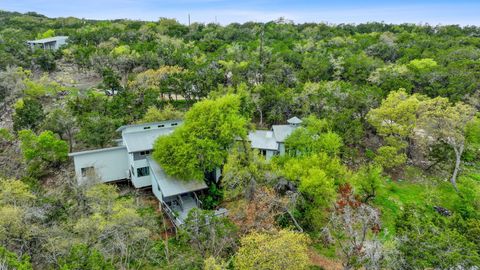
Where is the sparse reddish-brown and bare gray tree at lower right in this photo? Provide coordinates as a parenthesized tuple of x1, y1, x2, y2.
(323, 184, 382, 270)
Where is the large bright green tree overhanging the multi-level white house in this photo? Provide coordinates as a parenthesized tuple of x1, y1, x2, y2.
(153, 95, 247, 179)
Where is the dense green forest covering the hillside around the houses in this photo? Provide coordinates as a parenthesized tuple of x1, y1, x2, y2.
(0, 8, 480, 270)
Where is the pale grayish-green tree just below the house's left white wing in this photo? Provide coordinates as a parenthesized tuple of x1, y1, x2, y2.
(73, 184, 158, 269)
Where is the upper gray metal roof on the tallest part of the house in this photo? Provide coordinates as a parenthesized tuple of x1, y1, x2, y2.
(122, 127, 175, 153)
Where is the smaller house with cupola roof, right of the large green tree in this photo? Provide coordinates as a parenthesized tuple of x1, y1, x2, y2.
(248, 117, 302, 160)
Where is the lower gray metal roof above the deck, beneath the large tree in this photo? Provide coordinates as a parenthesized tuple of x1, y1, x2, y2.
(147, 157, 207, 197)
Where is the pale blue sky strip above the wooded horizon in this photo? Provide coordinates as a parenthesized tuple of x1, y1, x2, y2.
(0, 0, 480, 25)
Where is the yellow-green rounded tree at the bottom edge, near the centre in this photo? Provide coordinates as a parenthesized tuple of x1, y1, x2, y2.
(234, 230, 309, 270)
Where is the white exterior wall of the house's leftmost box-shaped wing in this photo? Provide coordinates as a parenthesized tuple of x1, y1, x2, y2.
(73, 147, 128, 184)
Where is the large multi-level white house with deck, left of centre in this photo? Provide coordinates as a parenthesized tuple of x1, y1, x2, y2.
(70, 120, 212, 226)
